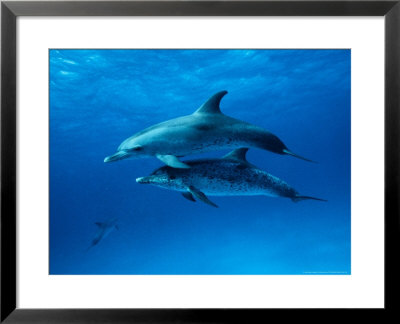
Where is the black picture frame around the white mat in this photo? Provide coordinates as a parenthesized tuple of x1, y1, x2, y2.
(0, 0, 400, 323)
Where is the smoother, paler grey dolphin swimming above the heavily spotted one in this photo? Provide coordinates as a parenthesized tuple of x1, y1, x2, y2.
(104, 91, 310, 168)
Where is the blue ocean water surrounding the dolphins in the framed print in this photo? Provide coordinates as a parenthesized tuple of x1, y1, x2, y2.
(49, 49, 351, 275)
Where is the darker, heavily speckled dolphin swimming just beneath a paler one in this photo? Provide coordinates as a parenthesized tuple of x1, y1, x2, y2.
(136, 148, 326, 207)
